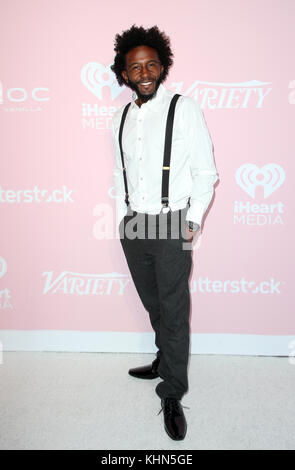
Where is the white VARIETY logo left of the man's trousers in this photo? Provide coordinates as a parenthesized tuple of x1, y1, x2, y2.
(43, 271, 129, 295)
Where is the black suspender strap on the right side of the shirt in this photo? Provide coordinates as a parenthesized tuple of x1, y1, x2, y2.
(161, 94, 181, 209)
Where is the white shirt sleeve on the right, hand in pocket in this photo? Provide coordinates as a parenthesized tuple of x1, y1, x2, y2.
(183, 97, 218, 226)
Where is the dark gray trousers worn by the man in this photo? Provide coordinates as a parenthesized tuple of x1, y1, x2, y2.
(119, 205, 192, 400)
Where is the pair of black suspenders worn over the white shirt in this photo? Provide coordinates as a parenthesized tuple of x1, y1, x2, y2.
(119, 94, 181, 209)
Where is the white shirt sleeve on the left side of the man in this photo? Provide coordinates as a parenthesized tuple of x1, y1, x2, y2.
(112, 115, 127, 226)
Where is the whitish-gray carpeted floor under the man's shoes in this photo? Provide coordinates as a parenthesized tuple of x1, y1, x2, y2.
(0, 352, 295, 450)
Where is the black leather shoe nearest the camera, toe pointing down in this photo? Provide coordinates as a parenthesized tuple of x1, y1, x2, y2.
(159, 398, 187, 441)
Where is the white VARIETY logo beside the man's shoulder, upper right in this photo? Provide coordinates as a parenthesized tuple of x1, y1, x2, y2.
(171, 80, 272, 109)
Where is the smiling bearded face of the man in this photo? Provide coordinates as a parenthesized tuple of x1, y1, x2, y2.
(122, 46, 164, 105)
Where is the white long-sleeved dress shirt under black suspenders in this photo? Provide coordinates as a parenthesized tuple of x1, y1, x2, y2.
(112, 84, 218, 226)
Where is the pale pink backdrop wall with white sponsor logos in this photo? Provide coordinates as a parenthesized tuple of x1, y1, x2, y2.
(0, 0, 295, 349)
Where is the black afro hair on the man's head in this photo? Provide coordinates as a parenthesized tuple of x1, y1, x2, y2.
(111, 24, 173, 86)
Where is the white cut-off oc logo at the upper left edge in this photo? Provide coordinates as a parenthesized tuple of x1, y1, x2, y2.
(0, 81, 50, 111)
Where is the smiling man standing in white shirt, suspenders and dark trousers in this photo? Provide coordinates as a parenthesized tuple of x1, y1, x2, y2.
(111, 25, 218, 440)
